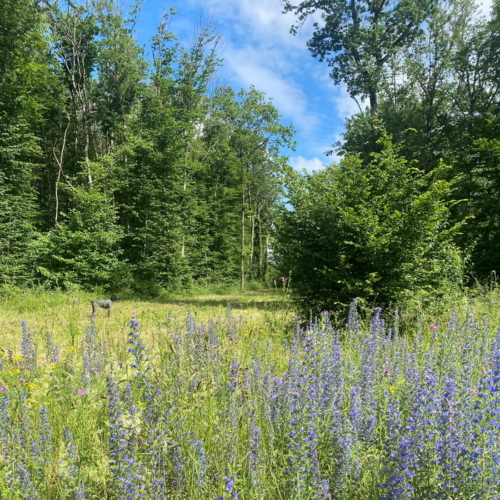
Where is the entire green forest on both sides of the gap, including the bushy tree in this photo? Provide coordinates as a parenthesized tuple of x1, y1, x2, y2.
(0, 0, 500, 311)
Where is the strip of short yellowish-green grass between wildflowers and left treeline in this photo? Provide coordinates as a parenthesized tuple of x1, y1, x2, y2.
(0, 290, 294, 354)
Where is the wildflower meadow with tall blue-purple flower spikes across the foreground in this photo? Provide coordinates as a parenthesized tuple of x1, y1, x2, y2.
(0, 292, 500, 500)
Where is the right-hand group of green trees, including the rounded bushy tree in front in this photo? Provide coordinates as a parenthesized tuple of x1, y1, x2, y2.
(279, 0, 500, 311)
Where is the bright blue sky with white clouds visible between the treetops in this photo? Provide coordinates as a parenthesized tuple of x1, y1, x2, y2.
(131, 0, 491, 172)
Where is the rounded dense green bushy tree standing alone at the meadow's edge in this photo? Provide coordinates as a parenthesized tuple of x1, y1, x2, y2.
(278, 136, 463, 312)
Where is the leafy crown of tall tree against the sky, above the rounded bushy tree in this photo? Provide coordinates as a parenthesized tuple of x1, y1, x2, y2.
(283, 0, 434, 116)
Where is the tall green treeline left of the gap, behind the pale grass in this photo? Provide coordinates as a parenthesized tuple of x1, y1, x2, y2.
(0, 0, 293, 292)
